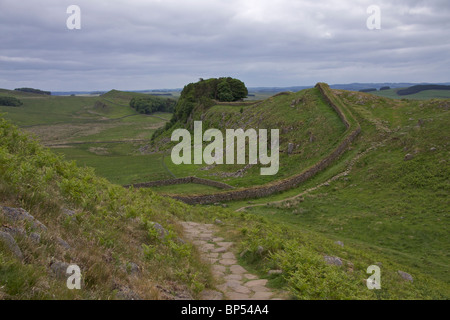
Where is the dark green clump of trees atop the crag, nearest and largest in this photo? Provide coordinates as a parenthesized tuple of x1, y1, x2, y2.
(152, 77, 248, 139)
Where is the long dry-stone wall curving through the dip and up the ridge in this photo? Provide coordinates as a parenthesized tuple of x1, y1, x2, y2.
(128, 83, 361, 204)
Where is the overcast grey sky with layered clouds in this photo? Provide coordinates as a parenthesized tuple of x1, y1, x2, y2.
(0, 0, 450, 91)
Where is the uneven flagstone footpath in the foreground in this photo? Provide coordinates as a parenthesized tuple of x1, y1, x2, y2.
(182, 222, 278, 300)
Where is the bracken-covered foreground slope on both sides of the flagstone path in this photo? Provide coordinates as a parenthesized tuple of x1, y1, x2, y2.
(0, 115, 448, 299)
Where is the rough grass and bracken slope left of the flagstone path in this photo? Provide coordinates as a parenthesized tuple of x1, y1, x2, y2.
(0, 119, 218, 299)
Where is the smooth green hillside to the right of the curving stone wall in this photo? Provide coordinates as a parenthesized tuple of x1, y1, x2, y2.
(231, 92, 450, 295)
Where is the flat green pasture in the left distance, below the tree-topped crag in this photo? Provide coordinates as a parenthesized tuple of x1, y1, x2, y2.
(0, 90, 175, 184)
